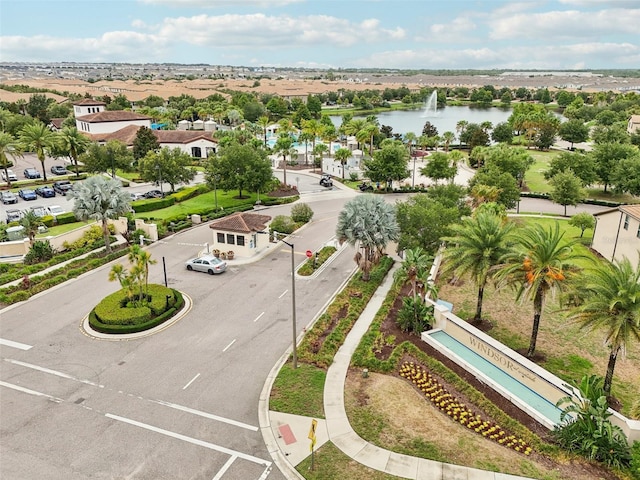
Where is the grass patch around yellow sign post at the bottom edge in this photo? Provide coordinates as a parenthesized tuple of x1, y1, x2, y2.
(296, 442, 401, 480)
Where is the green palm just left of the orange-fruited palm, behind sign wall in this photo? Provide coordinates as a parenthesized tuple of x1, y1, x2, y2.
(443, 212, 514, 324)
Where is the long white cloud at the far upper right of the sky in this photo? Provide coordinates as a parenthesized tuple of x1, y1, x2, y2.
(489, 9, 640, 43)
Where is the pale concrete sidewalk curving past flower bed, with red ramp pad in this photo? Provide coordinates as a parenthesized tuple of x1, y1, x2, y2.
(258, 259, 526, 480)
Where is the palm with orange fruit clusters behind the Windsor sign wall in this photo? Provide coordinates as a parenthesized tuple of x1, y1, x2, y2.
(496, 222, 588, 358)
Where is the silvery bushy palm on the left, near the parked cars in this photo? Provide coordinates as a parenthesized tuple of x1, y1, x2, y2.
(69, 175, 131, 252)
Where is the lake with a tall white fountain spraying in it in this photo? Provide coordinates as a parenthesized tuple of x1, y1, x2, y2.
(331, 106, 511, 137)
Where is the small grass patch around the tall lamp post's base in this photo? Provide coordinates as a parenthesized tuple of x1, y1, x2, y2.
(269, 363, 327, 418)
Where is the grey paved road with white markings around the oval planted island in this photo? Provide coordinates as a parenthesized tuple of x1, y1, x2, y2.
(0, 183, 354, 480)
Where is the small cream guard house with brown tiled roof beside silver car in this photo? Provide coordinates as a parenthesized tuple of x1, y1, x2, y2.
(209, 212, 271, 258)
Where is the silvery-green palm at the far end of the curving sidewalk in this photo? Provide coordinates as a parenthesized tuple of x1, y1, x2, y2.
(336, 194, 400, 282)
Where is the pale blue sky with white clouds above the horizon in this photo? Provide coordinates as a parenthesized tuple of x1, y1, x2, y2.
(0, 0, 640, 70)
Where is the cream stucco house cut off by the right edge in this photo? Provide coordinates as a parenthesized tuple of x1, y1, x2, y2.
(591, 205, 640, 267)
